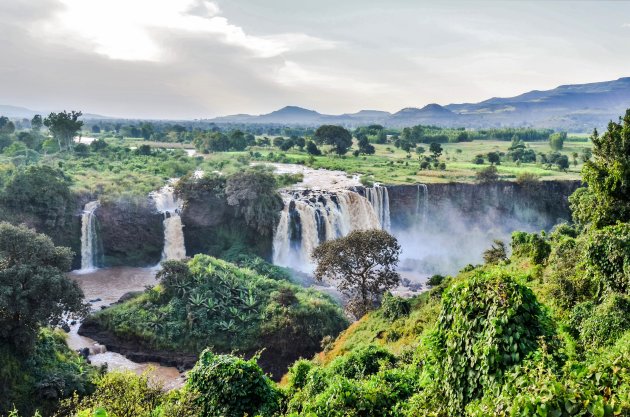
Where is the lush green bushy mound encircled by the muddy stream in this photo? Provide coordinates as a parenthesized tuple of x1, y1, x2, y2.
(91, 255, 346, 376)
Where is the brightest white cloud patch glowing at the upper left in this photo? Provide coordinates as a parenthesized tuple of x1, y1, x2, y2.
(44, 0, 335, 61)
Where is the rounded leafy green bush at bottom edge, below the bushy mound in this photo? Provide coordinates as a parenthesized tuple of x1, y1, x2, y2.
(186, 349, 279, 417)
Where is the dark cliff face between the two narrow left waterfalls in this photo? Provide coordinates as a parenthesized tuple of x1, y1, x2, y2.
(96, 198, 164, 266)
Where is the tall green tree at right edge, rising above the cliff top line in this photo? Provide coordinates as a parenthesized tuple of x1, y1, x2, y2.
(569, 109, 630, 228)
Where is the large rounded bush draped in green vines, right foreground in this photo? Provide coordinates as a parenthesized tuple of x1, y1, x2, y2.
(429, 274, 552, 415)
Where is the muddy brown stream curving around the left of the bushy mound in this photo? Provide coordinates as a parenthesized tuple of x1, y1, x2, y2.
(68, 267, 184, 390)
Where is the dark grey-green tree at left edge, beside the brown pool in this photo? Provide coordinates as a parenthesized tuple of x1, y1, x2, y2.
(0, 222, 87, 351)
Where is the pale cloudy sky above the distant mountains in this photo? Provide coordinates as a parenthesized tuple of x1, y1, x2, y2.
(0, 0, 630, 119)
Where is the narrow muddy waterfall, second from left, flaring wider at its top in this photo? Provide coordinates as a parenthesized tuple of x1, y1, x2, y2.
(150, 180, 186, 261)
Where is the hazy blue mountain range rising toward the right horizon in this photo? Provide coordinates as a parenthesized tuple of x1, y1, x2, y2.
(208, 77, 630, 131)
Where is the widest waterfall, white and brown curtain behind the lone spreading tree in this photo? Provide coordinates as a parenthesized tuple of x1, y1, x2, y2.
(273, 190, 381, 272)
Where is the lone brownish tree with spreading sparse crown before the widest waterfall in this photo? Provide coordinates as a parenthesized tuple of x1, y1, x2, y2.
(313, 230, 400, 318)
